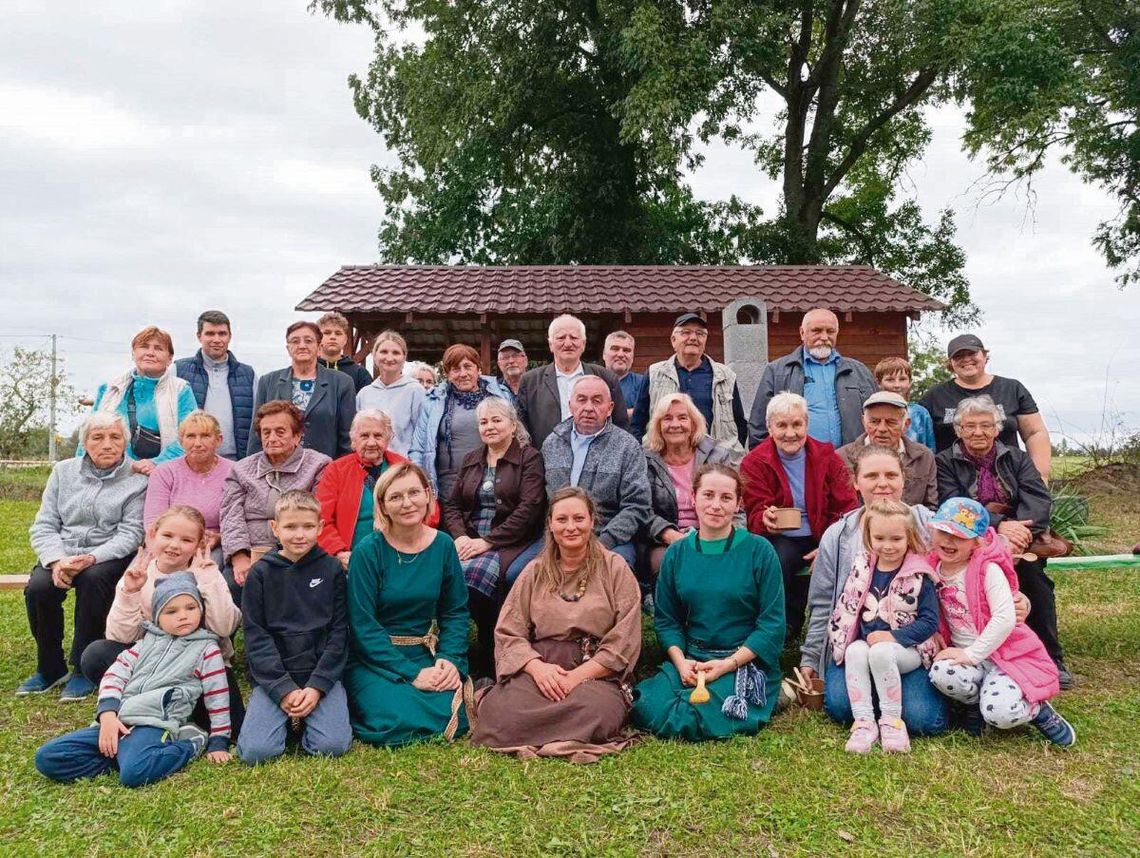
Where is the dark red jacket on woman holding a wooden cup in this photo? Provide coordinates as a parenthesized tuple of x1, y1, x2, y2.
(738, 436, 858, 539)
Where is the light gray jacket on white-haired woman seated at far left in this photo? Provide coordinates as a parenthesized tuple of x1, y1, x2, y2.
(29, 456, 146, 566)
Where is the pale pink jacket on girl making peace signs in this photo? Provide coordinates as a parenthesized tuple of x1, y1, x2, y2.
(104, 558, 242, 664)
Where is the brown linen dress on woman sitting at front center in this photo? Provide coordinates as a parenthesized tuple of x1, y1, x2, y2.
(471, 551, 641, 762)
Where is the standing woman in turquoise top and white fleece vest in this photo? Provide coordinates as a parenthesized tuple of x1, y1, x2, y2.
(75, 326, 198, 474)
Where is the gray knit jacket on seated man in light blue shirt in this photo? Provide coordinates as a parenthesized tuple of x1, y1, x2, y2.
(543, 418, 650, 548)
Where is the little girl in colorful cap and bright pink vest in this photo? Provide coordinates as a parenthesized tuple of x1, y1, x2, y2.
(930, 498, 1076, 747)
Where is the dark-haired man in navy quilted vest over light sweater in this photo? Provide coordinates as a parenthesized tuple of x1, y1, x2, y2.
(174, 310, 258, 459)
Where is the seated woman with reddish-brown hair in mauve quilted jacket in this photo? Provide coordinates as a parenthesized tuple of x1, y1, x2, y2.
(221, 401, 332, 605)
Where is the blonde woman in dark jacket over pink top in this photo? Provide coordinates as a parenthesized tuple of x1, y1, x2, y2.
(645, 393, 744, 577)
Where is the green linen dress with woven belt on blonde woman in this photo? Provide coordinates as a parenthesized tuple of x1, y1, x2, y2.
(344, 531, 469, 747)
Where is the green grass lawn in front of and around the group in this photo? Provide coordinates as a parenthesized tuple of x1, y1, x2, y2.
(0, 458, 1140, 857)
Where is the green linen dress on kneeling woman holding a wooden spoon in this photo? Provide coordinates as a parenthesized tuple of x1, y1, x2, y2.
(633, 528, 784, 742)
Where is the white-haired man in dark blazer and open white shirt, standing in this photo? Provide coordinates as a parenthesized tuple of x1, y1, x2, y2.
(515, 316, 629, 448)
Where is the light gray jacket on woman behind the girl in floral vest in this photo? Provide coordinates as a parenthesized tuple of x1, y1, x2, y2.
(799, 506, 934, 677)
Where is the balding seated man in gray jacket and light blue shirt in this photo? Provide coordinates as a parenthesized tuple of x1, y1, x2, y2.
(543, 375, 650, 567)
